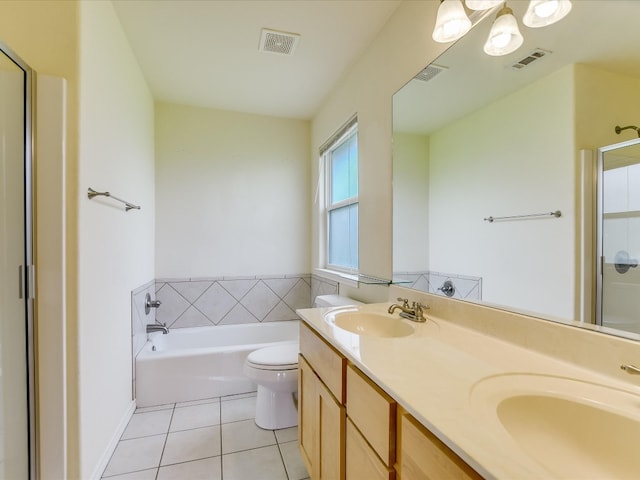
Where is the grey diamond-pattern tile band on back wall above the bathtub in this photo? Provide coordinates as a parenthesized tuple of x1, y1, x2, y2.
(155, 275, 311, 328)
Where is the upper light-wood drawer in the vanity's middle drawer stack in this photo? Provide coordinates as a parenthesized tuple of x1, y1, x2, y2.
(347, 365, 396, 466)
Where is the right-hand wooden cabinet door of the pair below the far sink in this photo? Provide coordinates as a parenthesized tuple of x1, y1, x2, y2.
(312, 380, 346, 480)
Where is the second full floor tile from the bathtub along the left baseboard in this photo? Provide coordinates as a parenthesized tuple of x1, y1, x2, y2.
(104, 435, 166, 477)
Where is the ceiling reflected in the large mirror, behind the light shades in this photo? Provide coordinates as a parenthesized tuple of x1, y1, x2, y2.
(393, 0, 640, 134)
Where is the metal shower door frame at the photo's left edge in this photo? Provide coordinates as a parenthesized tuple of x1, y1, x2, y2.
(0, 40, 38, 480)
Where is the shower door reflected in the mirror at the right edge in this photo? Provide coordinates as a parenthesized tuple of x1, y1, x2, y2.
(596, 138, 640, 334)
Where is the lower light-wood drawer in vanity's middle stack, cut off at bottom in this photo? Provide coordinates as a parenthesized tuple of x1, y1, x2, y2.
(346, 419, 396, 480)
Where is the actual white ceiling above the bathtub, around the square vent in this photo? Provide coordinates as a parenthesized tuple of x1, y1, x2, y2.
(113, 0, 401, 119)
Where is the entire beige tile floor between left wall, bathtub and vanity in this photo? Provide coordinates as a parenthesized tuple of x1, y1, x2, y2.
(102, 393, 308, 480)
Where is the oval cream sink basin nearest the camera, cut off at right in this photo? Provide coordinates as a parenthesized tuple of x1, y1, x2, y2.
(470, 374, 640, 479)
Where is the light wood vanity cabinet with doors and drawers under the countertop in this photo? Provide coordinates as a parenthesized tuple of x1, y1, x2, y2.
(298, 322, 482, 480)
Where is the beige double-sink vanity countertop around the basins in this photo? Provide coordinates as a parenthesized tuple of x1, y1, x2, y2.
(297, 303, 640, 479)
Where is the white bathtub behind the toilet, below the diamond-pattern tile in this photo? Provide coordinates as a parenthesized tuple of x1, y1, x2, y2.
(135, 320, 299, 407)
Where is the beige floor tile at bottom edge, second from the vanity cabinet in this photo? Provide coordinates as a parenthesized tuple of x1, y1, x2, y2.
(222, 445, 287, 480)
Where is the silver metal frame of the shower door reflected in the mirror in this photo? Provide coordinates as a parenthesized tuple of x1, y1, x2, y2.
(595, 137, 640, 325)
